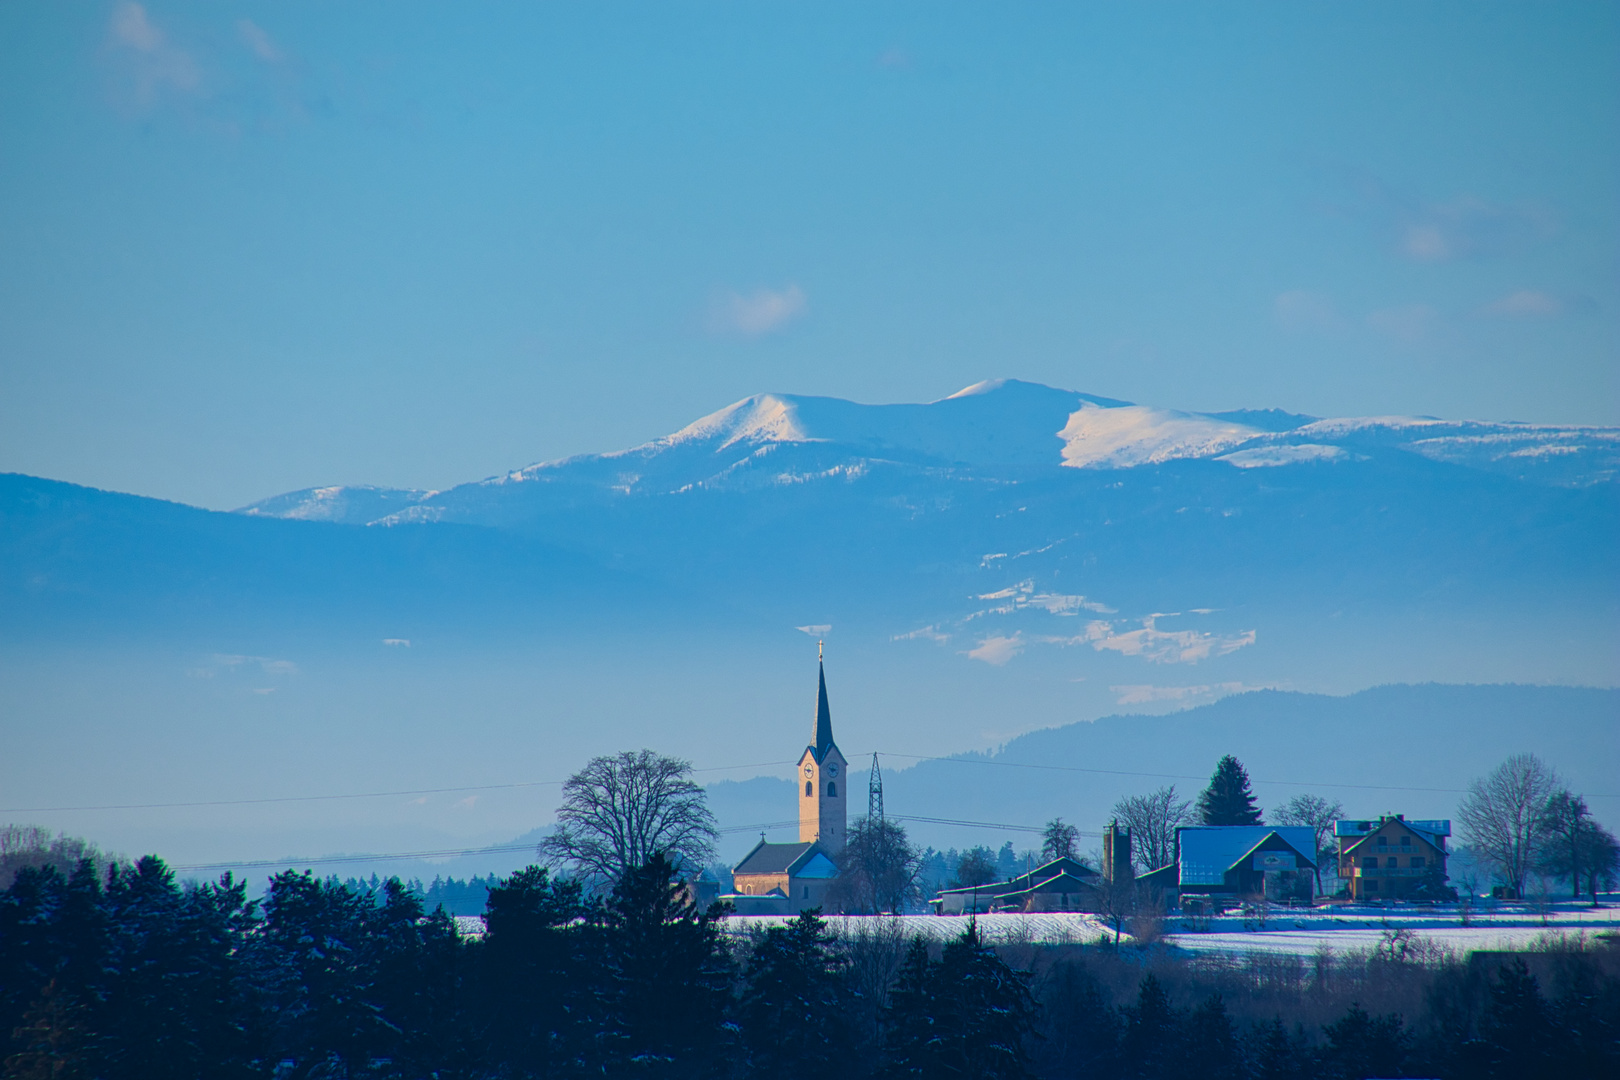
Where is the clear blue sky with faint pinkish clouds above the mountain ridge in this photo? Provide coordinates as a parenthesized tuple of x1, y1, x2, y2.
(0, 3, 1620, 508)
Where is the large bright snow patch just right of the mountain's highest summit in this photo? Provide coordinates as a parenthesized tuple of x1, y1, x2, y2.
(1058, 405, 1262, 468)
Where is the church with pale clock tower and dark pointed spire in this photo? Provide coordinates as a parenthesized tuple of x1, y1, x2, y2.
(721, 664, 849, 915)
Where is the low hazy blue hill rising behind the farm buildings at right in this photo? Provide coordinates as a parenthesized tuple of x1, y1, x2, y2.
(710, 683, 1620, 848)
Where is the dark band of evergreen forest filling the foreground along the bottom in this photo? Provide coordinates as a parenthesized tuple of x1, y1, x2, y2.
(0, 857, 1620, 1080)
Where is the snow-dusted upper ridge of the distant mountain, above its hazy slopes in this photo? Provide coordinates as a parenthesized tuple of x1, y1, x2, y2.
(241, 379, 1620, 526)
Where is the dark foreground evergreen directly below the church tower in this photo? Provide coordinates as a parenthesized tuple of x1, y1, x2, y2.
(742, 912, 855, 1080)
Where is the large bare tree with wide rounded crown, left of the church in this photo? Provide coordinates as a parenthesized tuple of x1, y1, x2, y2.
(539, 750, 716, 887)
